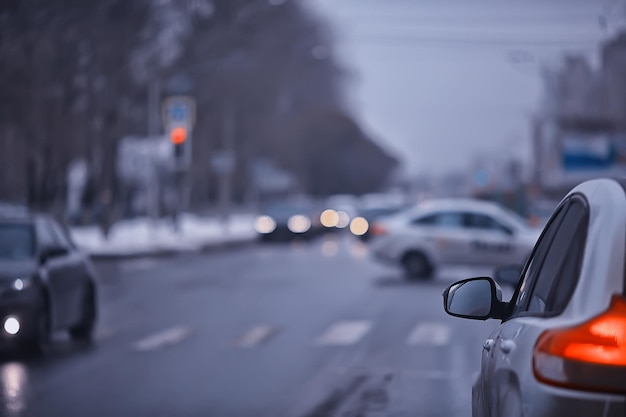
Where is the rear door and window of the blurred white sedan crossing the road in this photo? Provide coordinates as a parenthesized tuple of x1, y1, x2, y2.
(409, 211, 470, 264)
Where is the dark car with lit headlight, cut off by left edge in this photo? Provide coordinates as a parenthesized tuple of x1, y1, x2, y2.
(0, 211, 97, 353)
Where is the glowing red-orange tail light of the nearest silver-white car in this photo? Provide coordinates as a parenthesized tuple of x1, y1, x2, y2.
(533, 296, 626, 392)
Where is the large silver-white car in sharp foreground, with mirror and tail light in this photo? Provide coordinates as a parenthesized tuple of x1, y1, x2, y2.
(443, 179, 626, 417)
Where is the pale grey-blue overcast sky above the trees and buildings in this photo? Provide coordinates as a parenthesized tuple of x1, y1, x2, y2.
(304, 0, 626, 174)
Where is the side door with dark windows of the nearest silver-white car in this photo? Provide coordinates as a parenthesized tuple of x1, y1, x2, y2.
(481, 195, 589, 417)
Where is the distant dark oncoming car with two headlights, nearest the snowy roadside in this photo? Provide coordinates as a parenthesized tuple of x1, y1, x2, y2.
(254, 201, 323, 242)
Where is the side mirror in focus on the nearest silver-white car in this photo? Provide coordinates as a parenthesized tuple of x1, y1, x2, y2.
(443, 277, 504, 320)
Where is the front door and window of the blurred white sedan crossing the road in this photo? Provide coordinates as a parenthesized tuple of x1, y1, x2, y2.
(464, 212, 527, 266)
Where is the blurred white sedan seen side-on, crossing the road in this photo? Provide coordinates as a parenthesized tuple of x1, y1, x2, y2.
(370, 199, 541, 278)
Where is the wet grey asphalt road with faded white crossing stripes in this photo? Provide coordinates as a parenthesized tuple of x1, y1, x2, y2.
(0, 237, 497, 417)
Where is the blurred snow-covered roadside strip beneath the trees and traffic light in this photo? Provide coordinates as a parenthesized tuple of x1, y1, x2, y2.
(70, 214, 256, 258)
